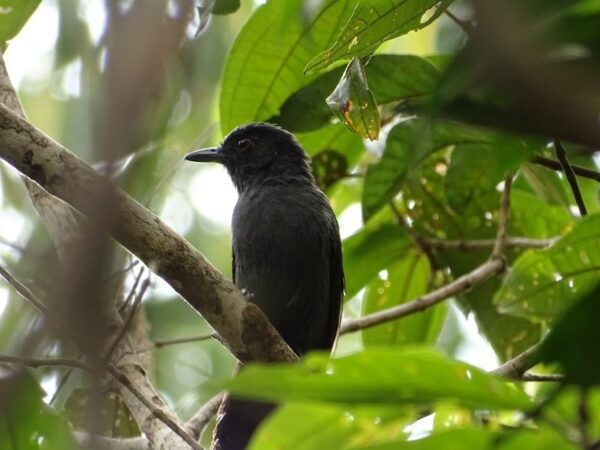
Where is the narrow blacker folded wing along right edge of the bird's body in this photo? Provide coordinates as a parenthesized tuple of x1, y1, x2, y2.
(327, 230, 344, 348)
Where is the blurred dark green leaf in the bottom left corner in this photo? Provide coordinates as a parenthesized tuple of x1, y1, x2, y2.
(0, 371, 76, 450)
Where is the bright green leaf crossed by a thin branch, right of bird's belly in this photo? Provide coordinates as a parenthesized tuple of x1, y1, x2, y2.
(362, 251, 446, 347)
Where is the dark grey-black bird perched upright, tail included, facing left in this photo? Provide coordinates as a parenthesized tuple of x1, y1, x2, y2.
(186, 123, 344, 450)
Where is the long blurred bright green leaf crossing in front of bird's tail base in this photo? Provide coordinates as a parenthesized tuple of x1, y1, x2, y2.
(228, 348, 531, 409)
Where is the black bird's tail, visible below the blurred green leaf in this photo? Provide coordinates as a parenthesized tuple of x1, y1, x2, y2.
(212, 396, 276, 450)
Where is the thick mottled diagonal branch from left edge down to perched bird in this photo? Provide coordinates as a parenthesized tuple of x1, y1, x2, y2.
(0, 105, 296, 362)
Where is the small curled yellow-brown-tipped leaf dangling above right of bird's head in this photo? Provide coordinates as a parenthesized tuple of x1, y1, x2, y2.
(325, 58, 381, 141)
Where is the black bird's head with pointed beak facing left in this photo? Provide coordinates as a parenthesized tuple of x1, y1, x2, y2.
(185, 123, 313, 192)
